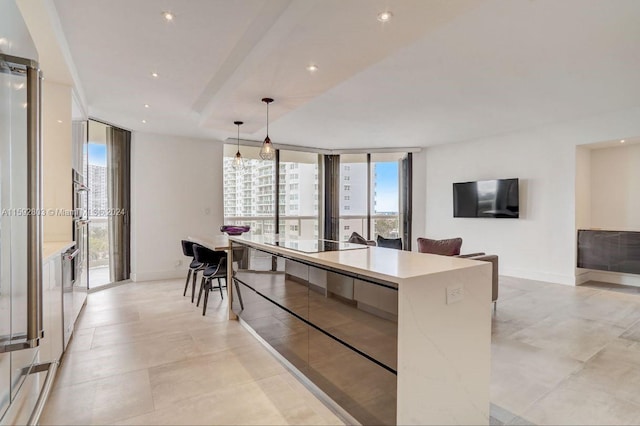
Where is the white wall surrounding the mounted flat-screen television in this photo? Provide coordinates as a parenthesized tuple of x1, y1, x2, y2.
(422, 108, 640, 284)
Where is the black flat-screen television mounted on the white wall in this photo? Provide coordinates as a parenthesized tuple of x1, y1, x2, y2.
(453, 178, 520, 219)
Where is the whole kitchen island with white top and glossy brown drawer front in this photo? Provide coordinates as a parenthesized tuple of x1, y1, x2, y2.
(229, 236, 491, 424)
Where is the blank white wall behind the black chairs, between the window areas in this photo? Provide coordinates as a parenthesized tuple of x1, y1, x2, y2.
(131, 132, 223, 281)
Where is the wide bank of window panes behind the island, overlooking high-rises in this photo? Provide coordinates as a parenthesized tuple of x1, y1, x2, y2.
(223, 144, 410, 246)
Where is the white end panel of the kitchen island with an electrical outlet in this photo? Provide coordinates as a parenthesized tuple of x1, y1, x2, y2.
(397, 262, 491, 425)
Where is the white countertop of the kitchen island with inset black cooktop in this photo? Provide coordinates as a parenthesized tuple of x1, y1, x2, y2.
(229, 235, 482, 283)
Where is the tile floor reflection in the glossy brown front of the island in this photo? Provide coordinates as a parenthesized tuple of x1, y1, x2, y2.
(234, 271, 398, 424)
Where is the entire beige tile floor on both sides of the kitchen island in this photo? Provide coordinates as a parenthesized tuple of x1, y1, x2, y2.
(41, 277, 640, 424)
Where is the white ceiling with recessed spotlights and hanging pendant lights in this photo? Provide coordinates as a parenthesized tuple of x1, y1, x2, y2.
(54, 0, 640, 149)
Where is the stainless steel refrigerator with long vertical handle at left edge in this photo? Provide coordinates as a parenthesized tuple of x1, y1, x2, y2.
(0, 0, 55, 424)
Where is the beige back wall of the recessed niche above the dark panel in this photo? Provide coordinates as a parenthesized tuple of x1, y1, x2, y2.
(590, 145, 640, 231)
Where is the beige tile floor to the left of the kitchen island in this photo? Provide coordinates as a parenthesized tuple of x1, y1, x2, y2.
(40, 280, 343, 425)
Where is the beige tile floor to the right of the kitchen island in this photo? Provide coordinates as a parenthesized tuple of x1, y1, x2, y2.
(491, 277, 640, 425)
